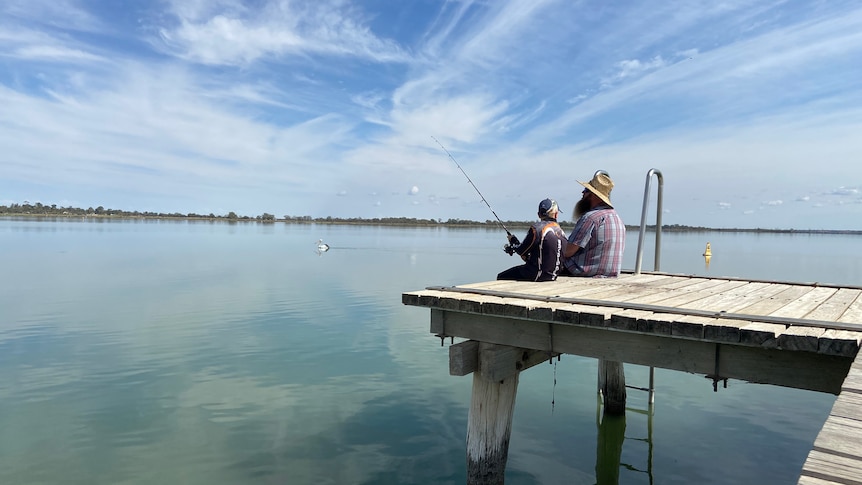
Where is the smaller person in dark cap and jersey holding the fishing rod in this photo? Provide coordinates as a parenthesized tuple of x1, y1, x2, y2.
(497, 199, 566, 281)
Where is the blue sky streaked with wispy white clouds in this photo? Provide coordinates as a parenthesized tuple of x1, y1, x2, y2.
(0, 0, 862, 229)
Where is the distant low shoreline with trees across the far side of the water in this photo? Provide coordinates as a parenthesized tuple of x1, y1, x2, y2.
(0, 210, 862, 236)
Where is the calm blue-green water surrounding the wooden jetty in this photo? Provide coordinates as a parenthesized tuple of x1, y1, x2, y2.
(0, 220, 862, 484)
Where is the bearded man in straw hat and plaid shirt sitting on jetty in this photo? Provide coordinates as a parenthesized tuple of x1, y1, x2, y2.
(560, 172, 626, 278)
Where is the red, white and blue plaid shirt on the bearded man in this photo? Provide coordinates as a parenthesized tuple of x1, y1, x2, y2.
(563, 205, 626, 277)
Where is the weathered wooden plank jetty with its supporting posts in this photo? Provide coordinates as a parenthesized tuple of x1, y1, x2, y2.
(402, 272, 862, 484)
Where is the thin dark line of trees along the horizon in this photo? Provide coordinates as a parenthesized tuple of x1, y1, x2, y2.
(0, 202, 862, 235)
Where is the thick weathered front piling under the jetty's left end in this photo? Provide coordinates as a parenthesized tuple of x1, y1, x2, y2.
(467, 372, 519, 485)
